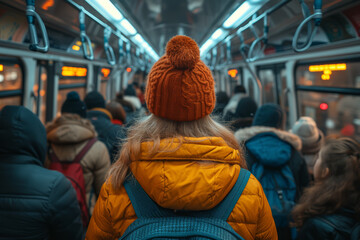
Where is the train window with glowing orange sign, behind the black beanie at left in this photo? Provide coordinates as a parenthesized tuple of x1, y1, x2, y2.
(57, 65, 87, 116)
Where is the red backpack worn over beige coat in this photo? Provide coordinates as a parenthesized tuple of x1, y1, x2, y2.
(49, 138, 97, 227)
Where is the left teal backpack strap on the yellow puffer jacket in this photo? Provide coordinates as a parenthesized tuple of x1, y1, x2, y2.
(124, 174, 173, 218)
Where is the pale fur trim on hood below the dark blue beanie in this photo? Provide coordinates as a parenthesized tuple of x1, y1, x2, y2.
(235, 126, 302, 151)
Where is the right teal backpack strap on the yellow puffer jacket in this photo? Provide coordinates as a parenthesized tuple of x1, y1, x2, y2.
(207, 168, 251, 221)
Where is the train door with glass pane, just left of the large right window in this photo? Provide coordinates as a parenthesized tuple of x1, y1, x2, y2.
(257, 64, 291, 129)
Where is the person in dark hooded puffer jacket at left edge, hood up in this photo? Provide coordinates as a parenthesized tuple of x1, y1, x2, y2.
(0, 106, 83, 240)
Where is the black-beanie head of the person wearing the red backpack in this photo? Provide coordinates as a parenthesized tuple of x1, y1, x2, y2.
(61, 91, 86, 118)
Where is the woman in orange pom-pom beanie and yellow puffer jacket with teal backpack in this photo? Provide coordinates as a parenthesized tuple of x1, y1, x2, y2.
(86, 36, 277, 240)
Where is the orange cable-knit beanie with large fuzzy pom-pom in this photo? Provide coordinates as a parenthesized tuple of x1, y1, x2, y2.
(146, 36, 215, 121)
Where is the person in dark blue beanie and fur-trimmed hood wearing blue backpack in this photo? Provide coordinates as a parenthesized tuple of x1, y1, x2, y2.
(235, 103, 309, 240)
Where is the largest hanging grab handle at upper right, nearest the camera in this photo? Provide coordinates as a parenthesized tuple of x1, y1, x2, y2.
(292, 0, 322, 52)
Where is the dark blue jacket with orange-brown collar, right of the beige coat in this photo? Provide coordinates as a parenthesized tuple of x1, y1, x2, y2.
(87, 108, 125, 162)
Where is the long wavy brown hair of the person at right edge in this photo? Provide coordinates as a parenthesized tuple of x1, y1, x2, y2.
(292, 138, 360, 227)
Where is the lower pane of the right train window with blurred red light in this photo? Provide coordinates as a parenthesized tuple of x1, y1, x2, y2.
(298, 91, 360, 140)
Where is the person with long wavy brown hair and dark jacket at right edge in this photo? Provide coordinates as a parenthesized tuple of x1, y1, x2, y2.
(293, 138, 360, 240)
